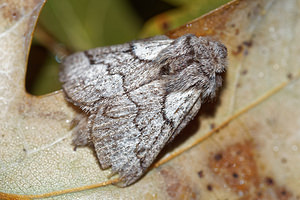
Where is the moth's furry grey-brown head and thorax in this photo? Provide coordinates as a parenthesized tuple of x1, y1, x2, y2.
(157, 34, 227, 98)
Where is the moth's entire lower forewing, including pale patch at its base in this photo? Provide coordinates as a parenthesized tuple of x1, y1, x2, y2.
(92, 78, 201, 186)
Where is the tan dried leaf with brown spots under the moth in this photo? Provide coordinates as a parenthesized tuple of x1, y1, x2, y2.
(0, 0, 300, 199)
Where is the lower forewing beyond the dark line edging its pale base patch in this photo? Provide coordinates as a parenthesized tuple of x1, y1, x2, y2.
(92, 81, 167, 186)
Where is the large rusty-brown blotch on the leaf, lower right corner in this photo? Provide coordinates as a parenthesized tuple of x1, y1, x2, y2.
(209, 141, 293, 200)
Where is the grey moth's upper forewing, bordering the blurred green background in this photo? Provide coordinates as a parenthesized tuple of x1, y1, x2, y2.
(60, 36, 173, 100)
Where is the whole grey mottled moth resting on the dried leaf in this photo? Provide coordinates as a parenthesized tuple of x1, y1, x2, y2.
(60, 34, 227, 186)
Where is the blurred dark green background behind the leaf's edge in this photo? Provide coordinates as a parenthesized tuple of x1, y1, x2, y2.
(26, 0, 229, 95)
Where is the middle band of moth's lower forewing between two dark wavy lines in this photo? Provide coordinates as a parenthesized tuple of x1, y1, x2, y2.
(130, 80, 171, 166)
